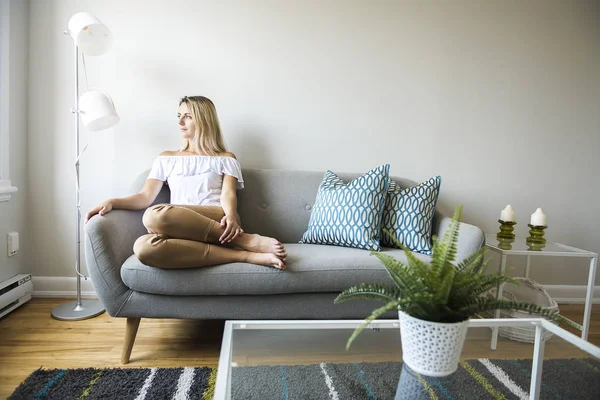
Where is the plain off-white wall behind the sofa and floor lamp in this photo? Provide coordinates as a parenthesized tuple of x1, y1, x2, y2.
(28, 0, 600, 285)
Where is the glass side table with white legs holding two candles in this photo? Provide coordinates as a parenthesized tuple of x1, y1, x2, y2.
(485, 233, 598, 350)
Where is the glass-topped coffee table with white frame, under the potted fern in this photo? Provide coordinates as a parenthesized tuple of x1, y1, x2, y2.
(214, 318, 600, 400)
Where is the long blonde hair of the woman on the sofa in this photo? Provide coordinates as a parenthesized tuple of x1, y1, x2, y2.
(179, 96, 227, 156)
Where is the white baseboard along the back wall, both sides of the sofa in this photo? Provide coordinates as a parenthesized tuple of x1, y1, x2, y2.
(32, 276, 600, 304)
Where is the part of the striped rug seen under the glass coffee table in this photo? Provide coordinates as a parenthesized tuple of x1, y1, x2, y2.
(232, 358, 600, 400)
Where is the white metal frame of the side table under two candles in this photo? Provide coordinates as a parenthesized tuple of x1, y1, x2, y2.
(486, 234, 598, 350)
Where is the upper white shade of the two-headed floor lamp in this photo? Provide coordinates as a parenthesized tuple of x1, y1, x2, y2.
(68, 12, 112, 56)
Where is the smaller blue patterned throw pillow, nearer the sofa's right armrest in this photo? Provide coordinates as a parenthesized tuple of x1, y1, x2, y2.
(381, 176, 442, 255)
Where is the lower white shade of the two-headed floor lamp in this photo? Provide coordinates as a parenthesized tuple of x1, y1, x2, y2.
(79, 89, 120, 131)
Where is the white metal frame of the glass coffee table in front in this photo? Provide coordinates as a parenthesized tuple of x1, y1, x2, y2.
(214, 318, 600, 400)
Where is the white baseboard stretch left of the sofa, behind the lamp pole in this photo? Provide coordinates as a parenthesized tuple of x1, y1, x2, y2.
(31, 276, 97, 299)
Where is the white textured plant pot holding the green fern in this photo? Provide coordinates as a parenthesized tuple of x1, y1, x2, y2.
(398, 311, 469, 377)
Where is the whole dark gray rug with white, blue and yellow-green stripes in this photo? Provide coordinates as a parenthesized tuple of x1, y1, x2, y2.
(9, 358, 600, 400)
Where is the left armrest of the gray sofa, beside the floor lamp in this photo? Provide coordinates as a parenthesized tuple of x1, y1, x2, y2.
(85, 210, 147, 316)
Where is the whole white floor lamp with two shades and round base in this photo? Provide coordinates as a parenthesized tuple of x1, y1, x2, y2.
(52, 13, 119, 321)
